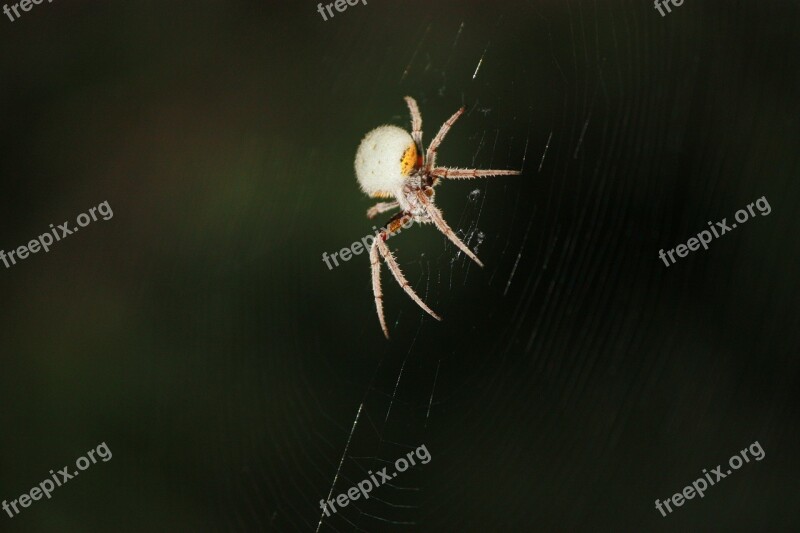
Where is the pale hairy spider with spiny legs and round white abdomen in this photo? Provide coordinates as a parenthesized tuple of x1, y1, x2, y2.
(355, 96, 520, 339)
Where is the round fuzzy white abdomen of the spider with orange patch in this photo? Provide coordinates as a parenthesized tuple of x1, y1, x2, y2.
(355, 126, 417, 198)
